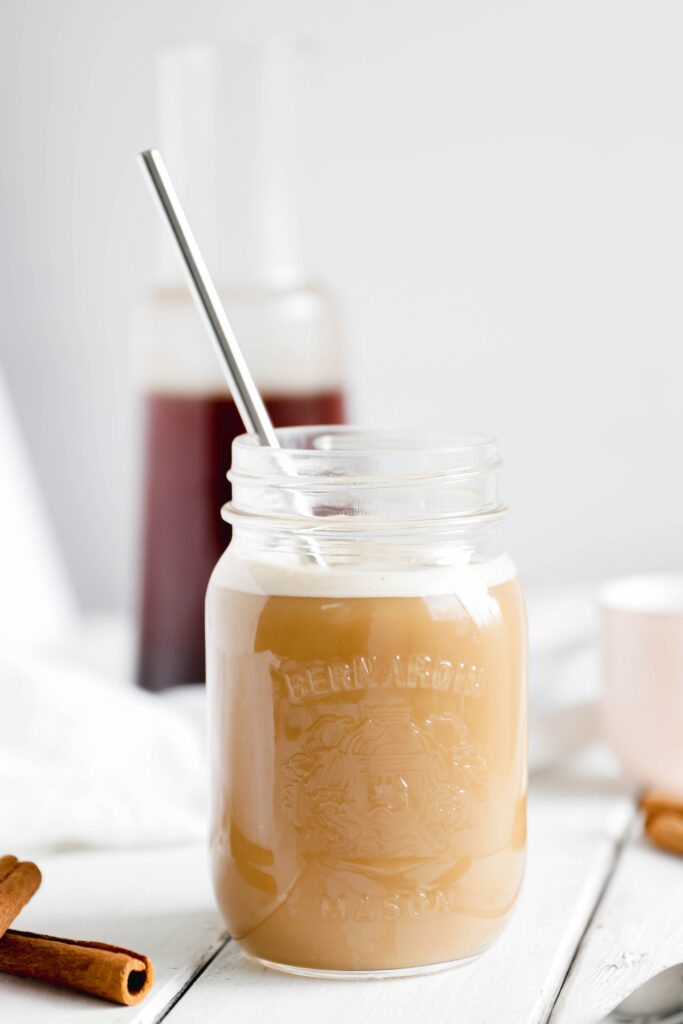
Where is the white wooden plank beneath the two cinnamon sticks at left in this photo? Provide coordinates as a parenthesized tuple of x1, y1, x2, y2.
(0, 847, 225, 1024)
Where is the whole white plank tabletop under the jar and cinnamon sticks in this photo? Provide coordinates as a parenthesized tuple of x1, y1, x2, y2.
(0, 773, 683, 1024)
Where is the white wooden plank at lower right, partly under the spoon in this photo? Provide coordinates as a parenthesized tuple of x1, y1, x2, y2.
(551, 827, 683, 1024)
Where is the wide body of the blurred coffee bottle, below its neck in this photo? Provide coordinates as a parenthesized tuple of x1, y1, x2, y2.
(137, 287, 344, 690)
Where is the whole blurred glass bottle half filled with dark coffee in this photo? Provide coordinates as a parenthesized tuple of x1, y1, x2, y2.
(137, 41, 344, 690)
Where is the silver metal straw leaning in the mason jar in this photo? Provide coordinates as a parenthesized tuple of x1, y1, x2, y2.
(140, 150, 325, 565)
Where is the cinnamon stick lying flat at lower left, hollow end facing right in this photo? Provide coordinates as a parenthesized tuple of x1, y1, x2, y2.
(0, 929, 154, 1007)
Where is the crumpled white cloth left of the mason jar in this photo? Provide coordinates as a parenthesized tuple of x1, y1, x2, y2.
(0, 653, 207, 852)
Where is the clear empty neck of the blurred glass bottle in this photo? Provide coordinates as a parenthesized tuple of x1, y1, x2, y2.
(157, 38, 306, 288)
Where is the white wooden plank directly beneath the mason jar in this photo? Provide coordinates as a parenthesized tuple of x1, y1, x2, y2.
(165, 781, 633, 1024)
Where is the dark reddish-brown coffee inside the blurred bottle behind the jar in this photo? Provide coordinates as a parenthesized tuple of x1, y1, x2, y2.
(138, 390, 344, 690)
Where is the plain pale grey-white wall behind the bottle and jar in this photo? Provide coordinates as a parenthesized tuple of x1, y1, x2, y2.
(0, 0, 683, 606)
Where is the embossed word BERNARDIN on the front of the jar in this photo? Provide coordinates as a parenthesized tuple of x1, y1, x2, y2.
(272, 654, 483, 703)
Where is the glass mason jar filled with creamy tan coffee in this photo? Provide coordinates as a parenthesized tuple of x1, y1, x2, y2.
(207, 427, 526, 977)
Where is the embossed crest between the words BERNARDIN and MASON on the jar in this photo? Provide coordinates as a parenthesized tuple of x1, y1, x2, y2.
(284, 702, 485, 870)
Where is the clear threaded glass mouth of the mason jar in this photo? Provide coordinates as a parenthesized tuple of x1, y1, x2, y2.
(228, 426, 504, 525)
